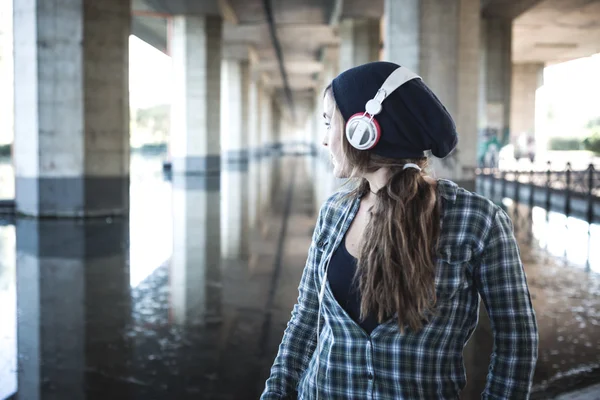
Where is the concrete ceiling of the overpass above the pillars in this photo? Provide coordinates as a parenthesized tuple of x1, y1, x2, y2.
(132, 0, 600, 120)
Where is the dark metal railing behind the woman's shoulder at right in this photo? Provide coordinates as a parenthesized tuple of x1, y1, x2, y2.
(476, 163, 600, 223)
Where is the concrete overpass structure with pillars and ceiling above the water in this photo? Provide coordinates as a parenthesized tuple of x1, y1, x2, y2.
(8, 0, 600, 219)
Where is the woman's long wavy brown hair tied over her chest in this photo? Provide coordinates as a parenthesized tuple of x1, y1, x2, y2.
(325, 86, 440, 332)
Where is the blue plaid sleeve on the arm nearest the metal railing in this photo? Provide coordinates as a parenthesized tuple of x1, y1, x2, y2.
(475, 209, 538, 400)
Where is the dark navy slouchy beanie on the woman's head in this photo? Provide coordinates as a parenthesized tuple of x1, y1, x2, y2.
(331, 61, 458, 158)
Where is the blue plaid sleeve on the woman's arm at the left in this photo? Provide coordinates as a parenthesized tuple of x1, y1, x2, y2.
(260, 205, 322, 400)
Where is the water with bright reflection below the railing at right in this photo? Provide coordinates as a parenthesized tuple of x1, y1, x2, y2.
(505, 201, 600, 399)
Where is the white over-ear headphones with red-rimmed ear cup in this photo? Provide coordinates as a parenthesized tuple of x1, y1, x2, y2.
(346, 67, 422, 150)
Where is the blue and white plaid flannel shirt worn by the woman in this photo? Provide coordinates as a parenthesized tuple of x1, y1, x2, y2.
(261, 179, 538, 400)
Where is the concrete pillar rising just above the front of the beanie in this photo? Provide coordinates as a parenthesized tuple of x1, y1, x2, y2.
(339, 18, 381, 71)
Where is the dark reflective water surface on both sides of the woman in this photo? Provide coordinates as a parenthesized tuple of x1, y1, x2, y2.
(0, 158, 600, 400)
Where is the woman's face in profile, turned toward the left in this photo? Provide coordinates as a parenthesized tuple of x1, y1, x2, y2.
(323, 91, 350, 178)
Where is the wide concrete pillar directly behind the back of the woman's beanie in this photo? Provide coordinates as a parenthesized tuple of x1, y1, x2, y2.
(384, 0, 480, 189)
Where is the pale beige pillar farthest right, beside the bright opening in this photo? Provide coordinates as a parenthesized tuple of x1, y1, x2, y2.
(510, 63, 544, 142)
